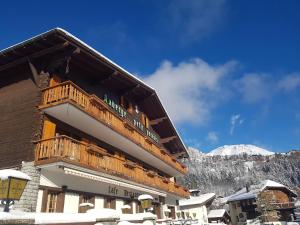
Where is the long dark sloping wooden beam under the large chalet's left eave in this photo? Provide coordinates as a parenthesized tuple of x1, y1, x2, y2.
(0, 42, 69, 72)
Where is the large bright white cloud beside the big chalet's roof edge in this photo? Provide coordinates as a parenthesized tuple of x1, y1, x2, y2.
(144, 58, 236, 124)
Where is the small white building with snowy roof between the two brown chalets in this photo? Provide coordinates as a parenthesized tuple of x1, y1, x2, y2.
(179, 191, 216, 224)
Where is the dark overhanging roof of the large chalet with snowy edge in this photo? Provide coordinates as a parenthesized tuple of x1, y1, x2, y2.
(0, 28, 188, 157)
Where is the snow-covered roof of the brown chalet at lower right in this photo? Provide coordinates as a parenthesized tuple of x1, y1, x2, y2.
(225, 180, 297, 202)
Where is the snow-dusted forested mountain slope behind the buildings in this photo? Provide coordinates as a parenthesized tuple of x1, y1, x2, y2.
(178, 145, 300, 196)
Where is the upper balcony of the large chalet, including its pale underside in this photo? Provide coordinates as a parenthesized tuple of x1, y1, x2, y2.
(39, 81, 187, 176)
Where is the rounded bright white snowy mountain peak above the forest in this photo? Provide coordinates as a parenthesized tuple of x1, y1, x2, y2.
(207, 144, 274, 156)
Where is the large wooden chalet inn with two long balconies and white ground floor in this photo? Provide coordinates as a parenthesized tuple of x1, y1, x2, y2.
(0, 28, 189, 218)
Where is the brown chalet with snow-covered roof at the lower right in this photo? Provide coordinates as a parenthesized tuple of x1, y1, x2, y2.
(227, 180, 297, 225)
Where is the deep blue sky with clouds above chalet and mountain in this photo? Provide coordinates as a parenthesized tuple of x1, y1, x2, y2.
(0, 0, 300, 152)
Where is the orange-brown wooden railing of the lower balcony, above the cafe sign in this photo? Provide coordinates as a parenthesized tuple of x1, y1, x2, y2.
(35, 135, 189, 197)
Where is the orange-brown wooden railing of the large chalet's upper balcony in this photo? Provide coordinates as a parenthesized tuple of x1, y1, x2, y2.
(40, 81, 187, 174)
